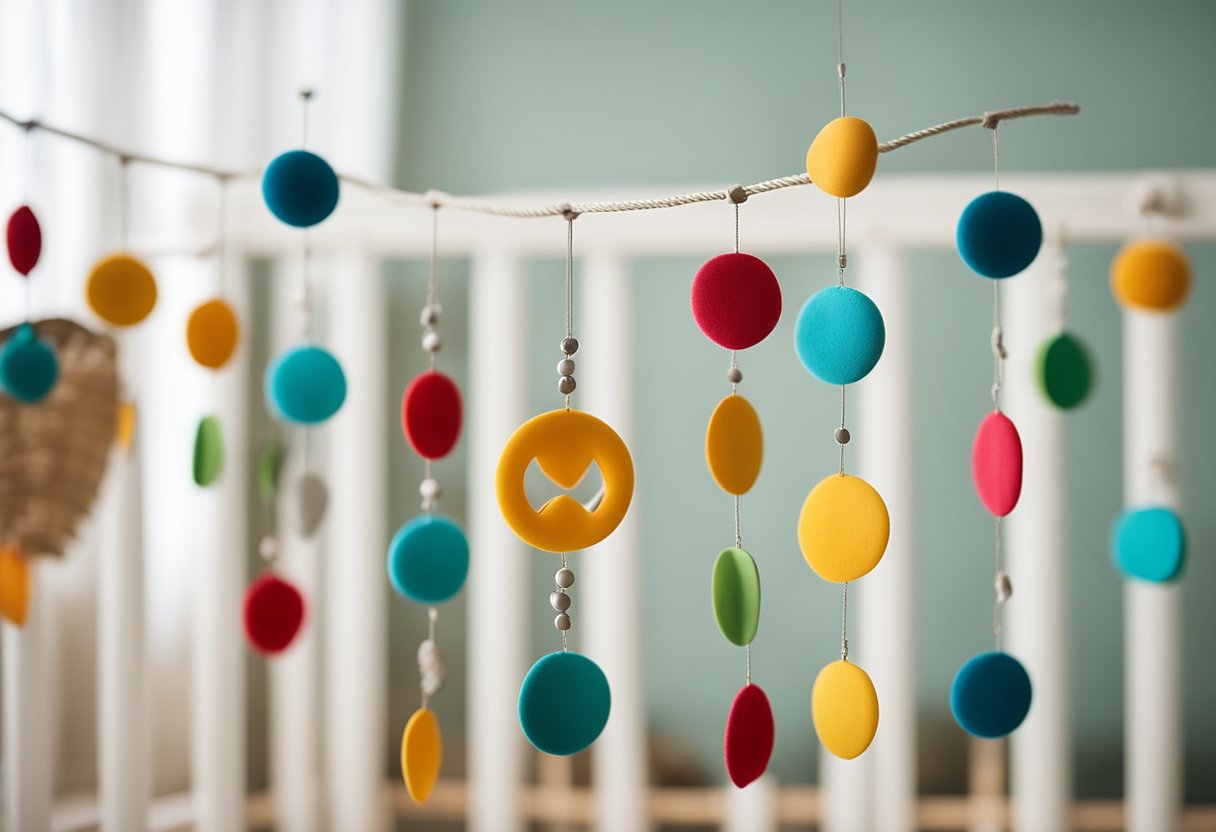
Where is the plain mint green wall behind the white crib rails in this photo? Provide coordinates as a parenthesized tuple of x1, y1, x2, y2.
(389, 0, 1216, 802)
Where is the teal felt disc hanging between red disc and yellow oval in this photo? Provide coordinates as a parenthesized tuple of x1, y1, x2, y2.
(388, 515, 468, 603)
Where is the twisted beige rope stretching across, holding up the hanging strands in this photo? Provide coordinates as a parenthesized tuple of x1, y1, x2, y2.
(0, 102, 1081, 219)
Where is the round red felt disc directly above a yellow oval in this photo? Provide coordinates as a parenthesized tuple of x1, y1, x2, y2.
(692, 253, 781, 349)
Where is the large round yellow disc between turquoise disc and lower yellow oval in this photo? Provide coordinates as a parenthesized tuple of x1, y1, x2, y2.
(798, 474, 891, 583)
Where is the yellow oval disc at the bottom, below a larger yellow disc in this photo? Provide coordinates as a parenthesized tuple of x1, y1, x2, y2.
(811, 659, 878, 760)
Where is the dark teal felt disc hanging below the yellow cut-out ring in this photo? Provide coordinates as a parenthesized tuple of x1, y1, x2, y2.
(519, 651, 612, 755)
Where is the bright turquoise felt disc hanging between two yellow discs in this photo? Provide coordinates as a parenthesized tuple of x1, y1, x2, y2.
(794, 286, 886, 384)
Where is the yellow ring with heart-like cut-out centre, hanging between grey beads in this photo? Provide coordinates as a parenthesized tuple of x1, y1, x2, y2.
(495, 410, 634, 552)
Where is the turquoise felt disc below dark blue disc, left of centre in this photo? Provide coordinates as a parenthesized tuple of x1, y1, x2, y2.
(265, 347, 347, 425)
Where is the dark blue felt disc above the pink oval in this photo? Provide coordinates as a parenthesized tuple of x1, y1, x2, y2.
(957, 191, 1043, 277)
